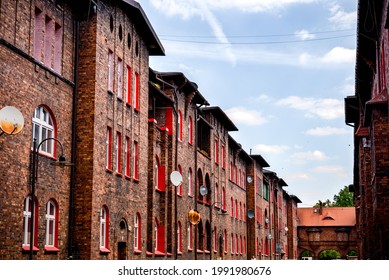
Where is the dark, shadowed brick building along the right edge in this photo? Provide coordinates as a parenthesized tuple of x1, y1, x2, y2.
(345, 0, 389, 259)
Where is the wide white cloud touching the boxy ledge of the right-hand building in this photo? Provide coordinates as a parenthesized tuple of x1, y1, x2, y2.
(277, 96, 344, 120)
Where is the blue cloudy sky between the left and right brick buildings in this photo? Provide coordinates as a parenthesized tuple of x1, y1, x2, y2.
(139, 0, 357, 207)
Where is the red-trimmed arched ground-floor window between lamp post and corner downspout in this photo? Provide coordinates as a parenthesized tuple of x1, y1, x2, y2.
(45, 199, 58, 250)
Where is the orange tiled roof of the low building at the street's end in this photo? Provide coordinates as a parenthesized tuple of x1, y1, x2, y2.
(297, 207, 356, 227)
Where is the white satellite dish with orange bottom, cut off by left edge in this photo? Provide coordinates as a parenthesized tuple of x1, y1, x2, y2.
(0, 106, 24, 135)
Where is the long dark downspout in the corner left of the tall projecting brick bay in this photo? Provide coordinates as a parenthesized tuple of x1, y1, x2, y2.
(68, 15, 80, 259)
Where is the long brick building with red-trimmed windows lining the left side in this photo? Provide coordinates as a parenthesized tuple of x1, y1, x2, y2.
(0, 0, 300, 260)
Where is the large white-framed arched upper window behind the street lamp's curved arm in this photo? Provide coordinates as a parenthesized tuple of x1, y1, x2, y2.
(32, 106, 55, 156)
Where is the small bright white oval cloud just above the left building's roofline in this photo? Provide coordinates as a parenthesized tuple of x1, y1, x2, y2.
(225, 107, 268, 126)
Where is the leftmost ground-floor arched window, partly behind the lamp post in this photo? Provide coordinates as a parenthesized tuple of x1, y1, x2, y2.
(23, 195, 38, 250)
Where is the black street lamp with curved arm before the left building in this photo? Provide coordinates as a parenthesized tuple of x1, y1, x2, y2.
(30, 137, 73, 260)
